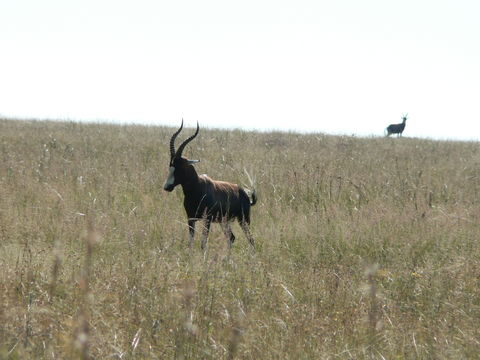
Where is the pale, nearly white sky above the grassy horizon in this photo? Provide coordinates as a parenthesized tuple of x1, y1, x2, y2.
(0, 0, 480, 139)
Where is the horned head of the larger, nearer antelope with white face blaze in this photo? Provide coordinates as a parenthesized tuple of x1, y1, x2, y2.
(163, 119, 200, 192)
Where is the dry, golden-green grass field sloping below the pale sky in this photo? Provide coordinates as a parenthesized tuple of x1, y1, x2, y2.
(0, 120, 480, 359)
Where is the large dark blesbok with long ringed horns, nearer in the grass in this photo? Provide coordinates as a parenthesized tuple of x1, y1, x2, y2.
(163, 119, 257, 249)
